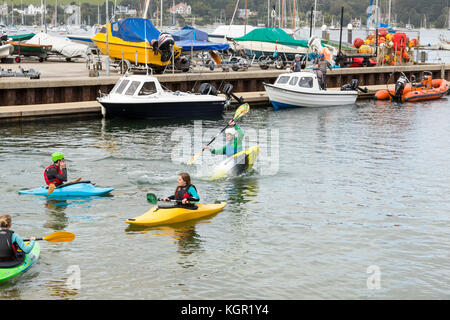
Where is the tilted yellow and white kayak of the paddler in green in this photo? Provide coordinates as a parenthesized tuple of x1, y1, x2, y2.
(211, 145, 259, 180)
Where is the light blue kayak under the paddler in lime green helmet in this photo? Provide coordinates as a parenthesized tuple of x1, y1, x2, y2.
(19, 182, 114, 197)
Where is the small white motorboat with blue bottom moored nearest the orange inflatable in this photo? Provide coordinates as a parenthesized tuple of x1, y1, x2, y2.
(263, 71, 358, 110)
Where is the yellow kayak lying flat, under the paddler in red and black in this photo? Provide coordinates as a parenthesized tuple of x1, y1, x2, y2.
(125, 202, 227, 227)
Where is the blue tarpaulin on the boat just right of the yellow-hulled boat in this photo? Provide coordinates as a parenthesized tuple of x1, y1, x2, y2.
(172, 26, 230, 52)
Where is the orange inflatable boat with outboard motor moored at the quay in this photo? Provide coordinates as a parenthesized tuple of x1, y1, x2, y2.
(375, 73, 449, 102)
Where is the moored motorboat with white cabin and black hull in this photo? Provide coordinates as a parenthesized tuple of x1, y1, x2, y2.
(97, 75, 232, 119)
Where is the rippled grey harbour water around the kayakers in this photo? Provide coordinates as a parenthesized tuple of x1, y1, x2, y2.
(0, 96, 450, 299)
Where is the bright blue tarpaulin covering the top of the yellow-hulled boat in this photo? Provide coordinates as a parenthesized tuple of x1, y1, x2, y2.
(111, 18, 160, 42)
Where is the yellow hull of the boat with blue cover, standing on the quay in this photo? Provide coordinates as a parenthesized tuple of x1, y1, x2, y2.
(91, 26, 181, 66)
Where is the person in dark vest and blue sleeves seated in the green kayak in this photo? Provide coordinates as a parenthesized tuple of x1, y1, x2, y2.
(0, 214, 36, 268)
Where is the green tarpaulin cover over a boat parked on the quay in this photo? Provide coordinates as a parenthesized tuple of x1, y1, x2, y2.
(233, 28, 308, 48)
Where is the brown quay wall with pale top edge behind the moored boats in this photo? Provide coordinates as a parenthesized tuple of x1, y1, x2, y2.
(0, 64, 450, 107)
